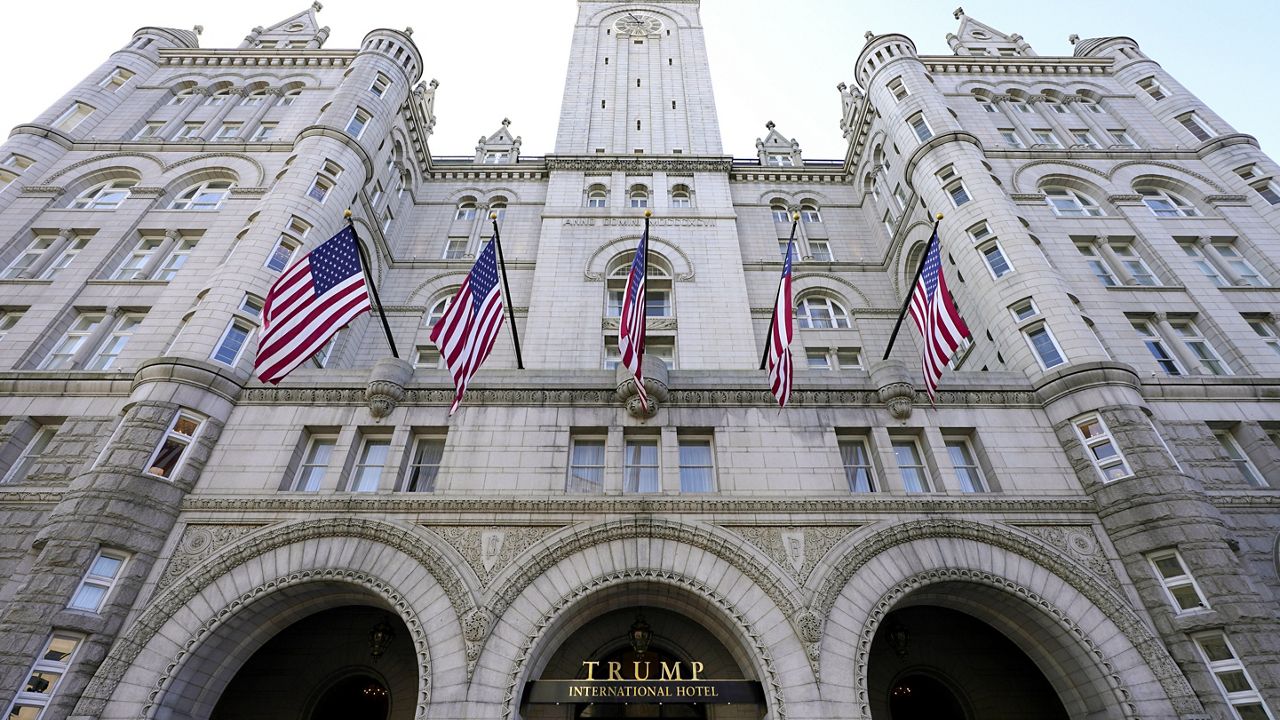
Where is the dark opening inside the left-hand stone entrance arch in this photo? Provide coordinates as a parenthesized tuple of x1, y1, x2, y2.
(211, 605, 417, 720)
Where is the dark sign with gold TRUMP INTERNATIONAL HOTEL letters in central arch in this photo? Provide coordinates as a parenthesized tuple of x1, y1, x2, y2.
(525, 661, 764, 705)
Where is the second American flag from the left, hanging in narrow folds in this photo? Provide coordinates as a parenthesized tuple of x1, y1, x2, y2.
(431, 240, 506, 415)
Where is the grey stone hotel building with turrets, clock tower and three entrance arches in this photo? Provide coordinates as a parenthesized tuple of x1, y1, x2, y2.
(0, 0, 1280, 720)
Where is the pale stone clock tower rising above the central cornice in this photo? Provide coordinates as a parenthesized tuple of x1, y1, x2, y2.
(556, 0, 722, 155)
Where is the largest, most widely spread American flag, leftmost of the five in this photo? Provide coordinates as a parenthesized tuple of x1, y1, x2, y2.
(253, 225, 370, 384)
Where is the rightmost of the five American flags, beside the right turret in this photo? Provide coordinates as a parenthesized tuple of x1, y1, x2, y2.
(910, 227, 970, 402)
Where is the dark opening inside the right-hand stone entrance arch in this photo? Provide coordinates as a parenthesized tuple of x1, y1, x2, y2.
(868, 605, 1068, 720)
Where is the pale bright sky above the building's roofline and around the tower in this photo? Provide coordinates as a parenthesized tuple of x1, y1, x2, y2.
(0, 0, 1280, 159)
